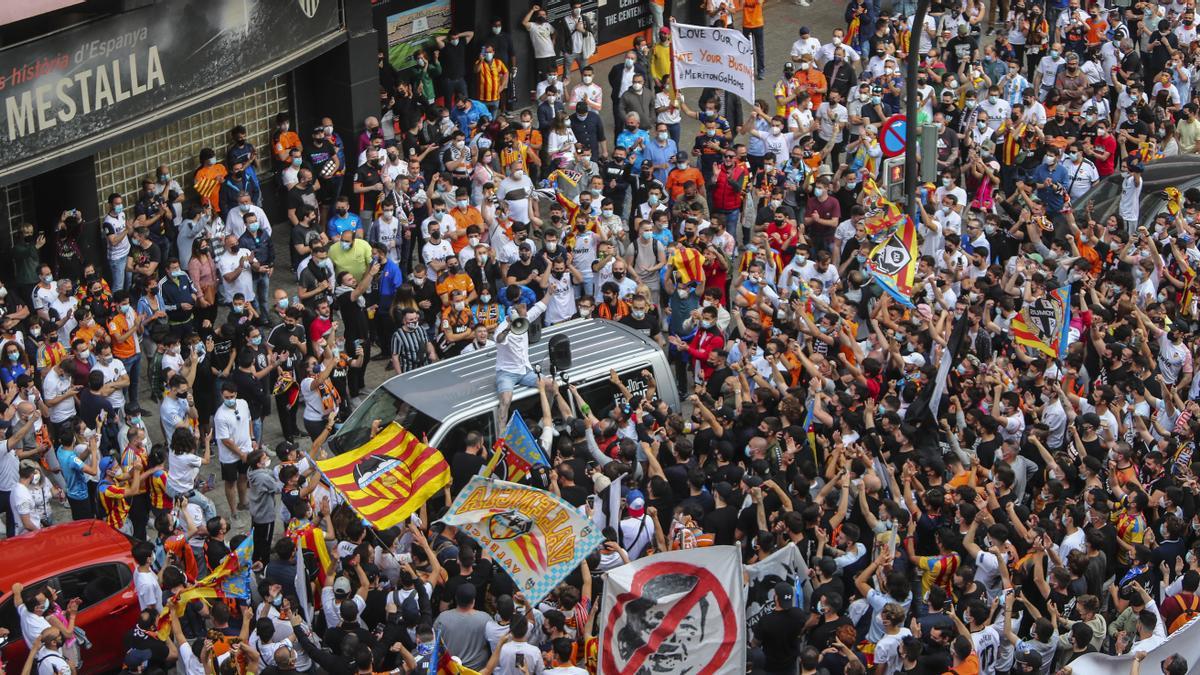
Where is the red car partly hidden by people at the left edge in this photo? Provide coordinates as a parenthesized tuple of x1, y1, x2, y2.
(0, 520, 138, 674)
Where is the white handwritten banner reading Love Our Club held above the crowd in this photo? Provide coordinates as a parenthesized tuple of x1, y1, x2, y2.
(671, 23, 755, 106)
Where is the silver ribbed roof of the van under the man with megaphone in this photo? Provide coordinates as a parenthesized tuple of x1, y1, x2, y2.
(383, 318, 661, 420)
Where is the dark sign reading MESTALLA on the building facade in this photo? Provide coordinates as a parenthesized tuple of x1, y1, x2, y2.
(0, 0, 342, 180)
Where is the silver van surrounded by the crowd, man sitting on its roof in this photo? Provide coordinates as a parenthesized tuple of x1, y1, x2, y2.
(329, 318, 679, 458)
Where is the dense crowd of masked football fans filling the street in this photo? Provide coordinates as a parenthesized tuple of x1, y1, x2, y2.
(11, 0, 1200, 675)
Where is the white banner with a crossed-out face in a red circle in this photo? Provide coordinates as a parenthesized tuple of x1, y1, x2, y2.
(599, 546, 746, 675)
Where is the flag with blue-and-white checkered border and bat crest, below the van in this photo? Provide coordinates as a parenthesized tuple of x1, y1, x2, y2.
(442, 476, 602, 604)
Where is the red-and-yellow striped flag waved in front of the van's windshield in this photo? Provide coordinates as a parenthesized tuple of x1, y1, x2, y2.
(317, 422, 450, 530)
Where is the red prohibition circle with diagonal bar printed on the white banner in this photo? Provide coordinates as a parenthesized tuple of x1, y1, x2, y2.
(600, 562, 738, 675)
